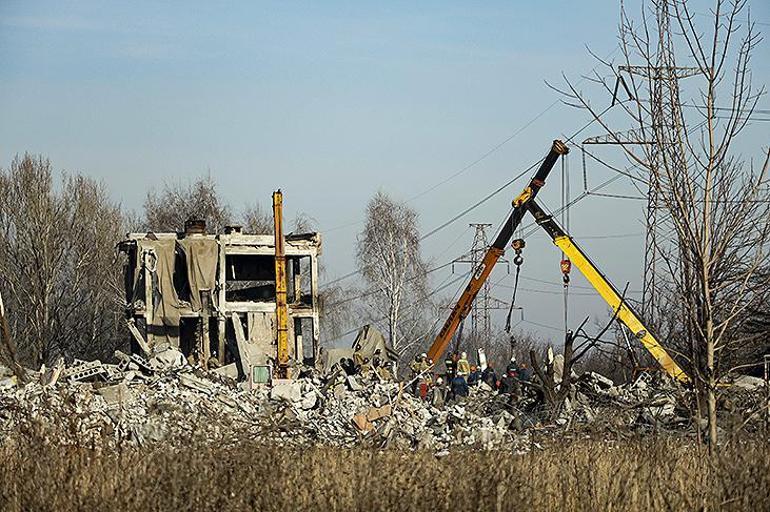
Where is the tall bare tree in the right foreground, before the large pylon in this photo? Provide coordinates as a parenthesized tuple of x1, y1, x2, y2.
(563, 0, 770, 453)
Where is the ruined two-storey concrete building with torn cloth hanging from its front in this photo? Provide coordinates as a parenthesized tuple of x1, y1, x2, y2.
(118, 214, 321, 382)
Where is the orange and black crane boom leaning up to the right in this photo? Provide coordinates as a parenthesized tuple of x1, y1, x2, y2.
(428, 140, 569, 362)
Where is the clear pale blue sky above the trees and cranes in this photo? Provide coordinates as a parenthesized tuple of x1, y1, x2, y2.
(0, 0, 770, 344)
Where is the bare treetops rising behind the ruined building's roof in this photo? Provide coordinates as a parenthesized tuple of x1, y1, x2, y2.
(144, 175, 230, 233)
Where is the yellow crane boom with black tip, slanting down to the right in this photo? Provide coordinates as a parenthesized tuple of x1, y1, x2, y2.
(528, 201, 690, 382)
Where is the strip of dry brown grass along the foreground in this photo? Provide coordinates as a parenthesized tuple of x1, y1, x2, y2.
(0, 434, 770, 512)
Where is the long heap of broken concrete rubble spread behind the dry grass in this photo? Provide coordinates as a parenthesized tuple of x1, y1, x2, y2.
(0, 358, 764, 457)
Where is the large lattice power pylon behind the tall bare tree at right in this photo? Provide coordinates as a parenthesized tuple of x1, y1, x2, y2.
(583, 0, 701, 320)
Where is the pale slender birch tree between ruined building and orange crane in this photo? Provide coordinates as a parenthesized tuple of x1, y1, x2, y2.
(357, 192, 429, 356)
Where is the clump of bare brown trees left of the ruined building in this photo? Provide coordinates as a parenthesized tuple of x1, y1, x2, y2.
(0, 155, 122, 365)
